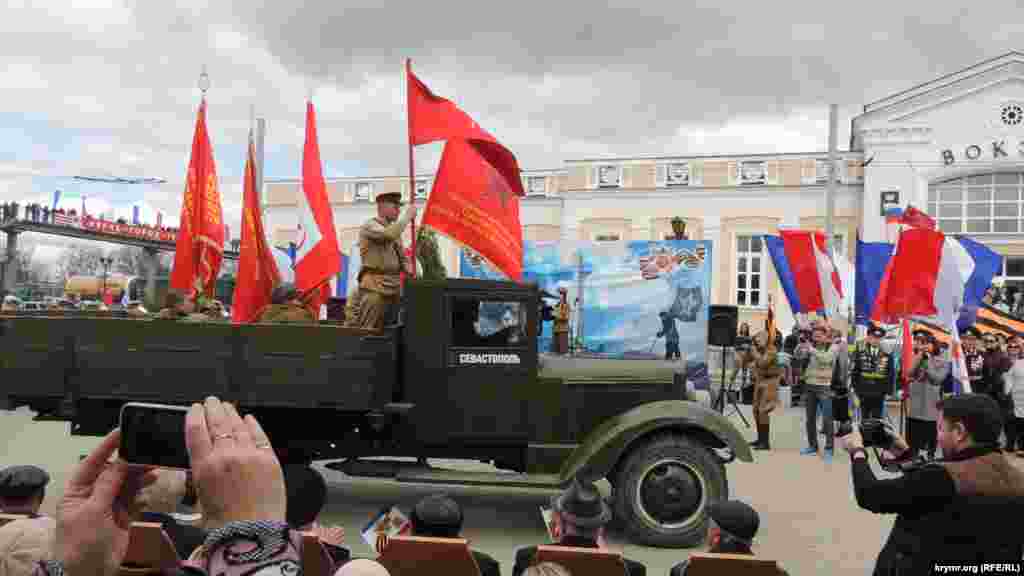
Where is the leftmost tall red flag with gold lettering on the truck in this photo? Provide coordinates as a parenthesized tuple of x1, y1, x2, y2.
(170, 99, 224, 296)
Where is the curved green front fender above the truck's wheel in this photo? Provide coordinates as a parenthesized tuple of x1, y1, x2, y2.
(559, 400, 754, 484)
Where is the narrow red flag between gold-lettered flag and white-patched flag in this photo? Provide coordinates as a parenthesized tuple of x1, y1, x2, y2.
(231, 127, 281, 324)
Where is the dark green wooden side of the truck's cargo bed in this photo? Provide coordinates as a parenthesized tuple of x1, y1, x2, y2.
(0, 317, 398, 416)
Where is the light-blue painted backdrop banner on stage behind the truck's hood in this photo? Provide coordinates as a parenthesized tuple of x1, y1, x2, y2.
(460, 240, 712, 366)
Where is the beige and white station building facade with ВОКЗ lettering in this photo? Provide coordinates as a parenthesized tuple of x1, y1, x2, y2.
(263, 53, 1024, 334)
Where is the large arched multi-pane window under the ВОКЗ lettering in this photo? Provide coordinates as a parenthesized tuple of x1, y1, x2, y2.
(928, 172, 1024, 234)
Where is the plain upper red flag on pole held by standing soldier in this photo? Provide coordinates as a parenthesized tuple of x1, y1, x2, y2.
(408, 70, 526, 196)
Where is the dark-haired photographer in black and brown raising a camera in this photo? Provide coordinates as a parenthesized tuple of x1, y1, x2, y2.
(840, 394, 1024, 576)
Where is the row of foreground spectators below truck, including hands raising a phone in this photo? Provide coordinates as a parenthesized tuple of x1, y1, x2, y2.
(0, 398, 778, 576)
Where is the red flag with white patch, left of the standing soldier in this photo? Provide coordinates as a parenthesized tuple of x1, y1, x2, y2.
(295, 101, 341, 315)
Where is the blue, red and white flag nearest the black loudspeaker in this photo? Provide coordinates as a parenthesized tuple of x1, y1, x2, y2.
(765, 230, 843, 316)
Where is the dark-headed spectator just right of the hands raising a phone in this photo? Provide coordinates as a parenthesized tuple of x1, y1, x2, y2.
(285, 465, 351, 565)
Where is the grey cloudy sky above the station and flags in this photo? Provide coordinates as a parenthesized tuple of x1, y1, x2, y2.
(0, 0, 1024, 235)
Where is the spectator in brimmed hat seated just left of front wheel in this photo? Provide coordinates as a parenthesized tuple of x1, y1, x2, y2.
(512, 479, 647, 576)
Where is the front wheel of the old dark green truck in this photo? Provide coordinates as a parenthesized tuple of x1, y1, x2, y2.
(614, 435, 729, 548)
